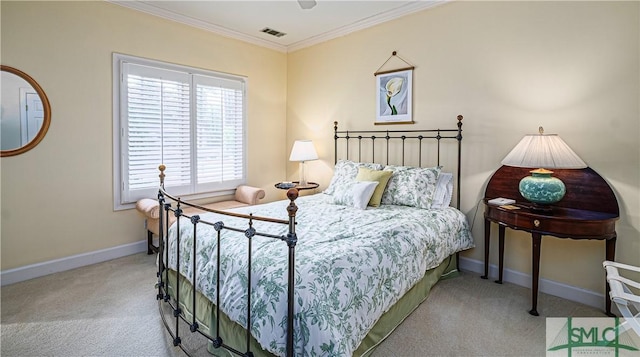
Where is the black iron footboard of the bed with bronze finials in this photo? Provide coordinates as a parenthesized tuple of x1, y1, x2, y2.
(156, 165, 298, 357)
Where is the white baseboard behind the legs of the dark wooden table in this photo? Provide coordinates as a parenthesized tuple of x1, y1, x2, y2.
(460, 257, 605, 310)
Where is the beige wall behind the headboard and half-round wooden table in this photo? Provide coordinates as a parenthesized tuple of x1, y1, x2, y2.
(287, 1, 640, 292)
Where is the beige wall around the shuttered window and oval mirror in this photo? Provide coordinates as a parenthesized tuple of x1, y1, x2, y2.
(0, 1, 287, 270)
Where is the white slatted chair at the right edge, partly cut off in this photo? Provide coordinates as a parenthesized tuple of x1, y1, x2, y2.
(602, 260, 640, 336)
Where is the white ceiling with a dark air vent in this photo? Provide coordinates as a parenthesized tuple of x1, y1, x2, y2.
(110, 0, 448, 52)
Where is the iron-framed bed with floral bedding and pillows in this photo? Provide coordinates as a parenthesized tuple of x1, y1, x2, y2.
(157, 116, 473, 356)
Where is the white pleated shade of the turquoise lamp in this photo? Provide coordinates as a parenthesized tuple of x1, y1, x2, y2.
(502, 128, 587, 169)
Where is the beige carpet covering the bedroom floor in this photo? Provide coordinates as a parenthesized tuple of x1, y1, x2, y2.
(0, 254, 605, 357)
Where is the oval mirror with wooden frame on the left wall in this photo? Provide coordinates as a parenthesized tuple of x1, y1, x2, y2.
(0, 65, 51, 157)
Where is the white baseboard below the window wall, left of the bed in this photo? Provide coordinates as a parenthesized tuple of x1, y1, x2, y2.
(0, 240, 147, 286)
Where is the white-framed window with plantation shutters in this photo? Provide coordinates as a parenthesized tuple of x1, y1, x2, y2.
(113, 54, 246, 209)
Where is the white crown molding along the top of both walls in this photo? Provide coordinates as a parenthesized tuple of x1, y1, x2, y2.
(107, 0, 454, 53)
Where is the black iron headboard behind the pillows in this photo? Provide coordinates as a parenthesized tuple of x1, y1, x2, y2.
(333, 115, 463, 209)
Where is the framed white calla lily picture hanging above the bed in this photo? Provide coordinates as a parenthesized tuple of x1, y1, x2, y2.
(375, 68, 413, 125)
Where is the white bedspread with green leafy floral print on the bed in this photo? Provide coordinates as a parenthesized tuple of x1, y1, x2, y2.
(168, 193, 473, 356)
